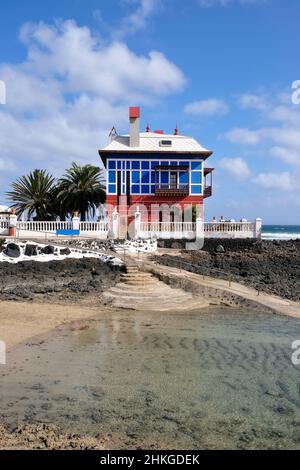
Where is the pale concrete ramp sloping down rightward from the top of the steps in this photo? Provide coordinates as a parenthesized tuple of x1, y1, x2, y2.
(134, 255, 300, 318)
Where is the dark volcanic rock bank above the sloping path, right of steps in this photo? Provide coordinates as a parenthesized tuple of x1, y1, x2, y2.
(154, 239, 300, 301)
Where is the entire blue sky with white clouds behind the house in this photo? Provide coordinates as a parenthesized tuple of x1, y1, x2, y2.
(0, 0, 300, 224)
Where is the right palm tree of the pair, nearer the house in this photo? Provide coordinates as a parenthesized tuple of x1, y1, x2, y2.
(58, 162, 105, 221)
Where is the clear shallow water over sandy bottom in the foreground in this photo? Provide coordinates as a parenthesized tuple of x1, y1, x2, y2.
(0, 309, 300, 449)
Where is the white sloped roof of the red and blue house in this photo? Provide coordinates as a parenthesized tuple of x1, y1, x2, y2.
(99, 132, 212, 156)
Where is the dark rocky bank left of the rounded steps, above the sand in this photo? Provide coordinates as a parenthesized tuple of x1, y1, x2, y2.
(0, 258, 124, 303)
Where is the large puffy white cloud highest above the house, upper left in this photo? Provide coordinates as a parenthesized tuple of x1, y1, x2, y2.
(17, 20, 185, 101)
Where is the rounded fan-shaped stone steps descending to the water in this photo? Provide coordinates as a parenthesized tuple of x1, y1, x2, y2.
(103, 264, 209, 311)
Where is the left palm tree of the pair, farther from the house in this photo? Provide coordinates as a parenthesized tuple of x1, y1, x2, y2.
(6, 170, 55, 220)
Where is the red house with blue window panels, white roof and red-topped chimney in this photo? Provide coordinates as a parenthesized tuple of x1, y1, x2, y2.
(99, 107, 213, 231)
